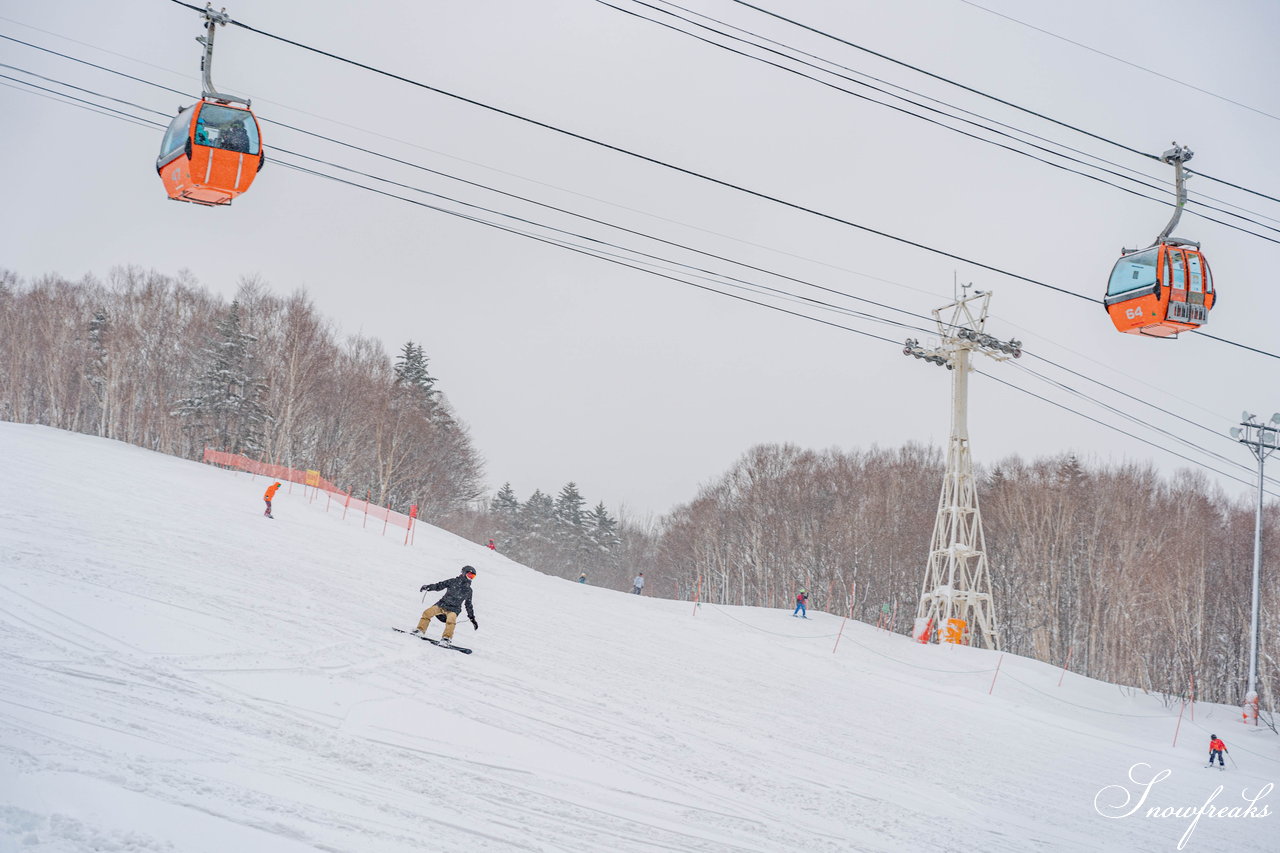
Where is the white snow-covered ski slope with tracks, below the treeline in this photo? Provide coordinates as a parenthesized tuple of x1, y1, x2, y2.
(0, 424, 1280, 853)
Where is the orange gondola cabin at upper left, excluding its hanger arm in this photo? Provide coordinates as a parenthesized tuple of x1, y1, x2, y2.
(156, 100, 266, 205)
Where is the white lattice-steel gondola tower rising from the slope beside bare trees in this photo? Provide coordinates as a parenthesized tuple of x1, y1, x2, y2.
(902, 286, 1021, 649)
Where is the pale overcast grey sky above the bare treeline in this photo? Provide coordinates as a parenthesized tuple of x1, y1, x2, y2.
(0, 0, 1280, 515)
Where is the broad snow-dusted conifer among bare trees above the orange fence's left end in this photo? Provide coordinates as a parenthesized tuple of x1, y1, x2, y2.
(173, 302, 271, 455)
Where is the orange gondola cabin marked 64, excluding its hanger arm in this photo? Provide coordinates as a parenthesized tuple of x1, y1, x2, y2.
(1103, 242, 1216, 338)
